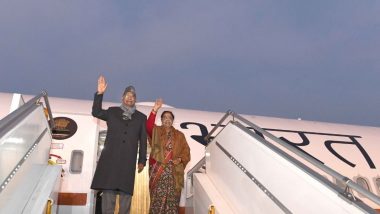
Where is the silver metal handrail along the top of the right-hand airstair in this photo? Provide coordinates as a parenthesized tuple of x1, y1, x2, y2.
(200, 110, 380, 205)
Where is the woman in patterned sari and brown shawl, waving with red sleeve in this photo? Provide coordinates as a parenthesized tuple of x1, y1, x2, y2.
(146, 99, 190, 214)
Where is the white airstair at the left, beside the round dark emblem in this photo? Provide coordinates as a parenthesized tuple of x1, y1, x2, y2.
(0, 92, 61, 214)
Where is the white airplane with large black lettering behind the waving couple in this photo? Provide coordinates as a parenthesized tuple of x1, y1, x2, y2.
(0, 93, 380, 213)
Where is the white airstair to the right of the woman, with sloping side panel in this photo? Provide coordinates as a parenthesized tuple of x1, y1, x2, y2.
(186, 111, 380, 214)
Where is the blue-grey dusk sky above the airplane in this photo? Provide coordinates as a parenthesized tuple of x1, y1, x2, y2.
(0, 0, 380, 126)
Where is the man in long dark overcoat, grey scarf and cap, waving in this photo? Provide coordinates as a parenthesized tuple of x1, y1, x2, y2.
(91, 76, 147, 214)
